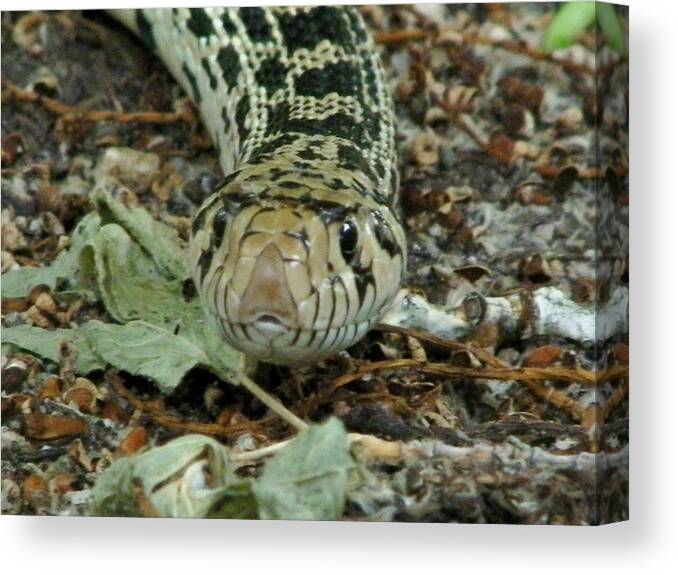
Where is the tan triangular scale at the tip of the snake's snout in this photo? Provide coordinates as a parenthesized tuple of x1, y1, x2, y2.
(239, 242, 299, 331)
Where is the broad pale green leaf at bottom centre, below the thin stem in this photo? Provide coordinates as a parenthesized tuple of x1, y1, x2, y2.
(252, 418, 354, 520)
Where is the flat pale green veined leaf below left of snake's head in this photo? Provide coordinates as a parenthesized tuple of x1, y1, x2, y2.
(84, 321, 210, 394)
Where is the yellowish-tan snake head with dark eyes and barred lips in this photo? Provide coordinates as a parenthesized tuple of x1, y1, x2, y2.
(190, 173, 405, 365)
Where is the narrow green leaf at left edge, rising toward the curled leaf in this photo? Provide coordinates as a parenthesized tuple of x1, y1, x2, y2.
(2, 213, 101, 298)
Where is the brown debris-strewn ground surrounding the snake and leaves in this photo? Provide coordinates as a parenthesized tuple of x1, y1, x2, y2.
(2, 4, 629, 525)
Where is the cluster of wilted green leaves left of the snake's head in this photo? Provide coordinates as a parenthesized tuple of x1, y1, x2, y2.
(3, 190, 244, 394)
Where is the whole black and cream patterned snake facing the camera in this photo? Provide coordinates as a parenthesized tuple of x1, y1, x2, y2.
(109, 6, 407, 365)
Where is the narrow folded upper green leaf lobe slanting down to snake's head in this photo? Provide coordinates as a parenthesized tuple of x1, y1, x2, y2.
(94, 188, 190, 280)
